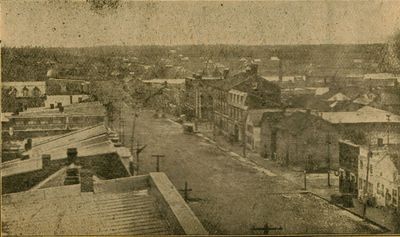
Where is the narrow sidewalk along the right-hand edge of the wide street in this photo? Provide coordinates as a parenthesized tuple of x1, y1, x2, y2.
(197, 121, 400, 233)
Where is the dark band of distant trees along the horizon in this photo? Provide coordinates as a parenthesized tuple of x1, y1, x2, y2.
(1, 44, 386, 81)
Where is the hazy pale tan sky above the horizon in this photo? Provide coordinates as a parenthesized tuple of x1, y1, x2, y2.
(0, 0, 400, 47)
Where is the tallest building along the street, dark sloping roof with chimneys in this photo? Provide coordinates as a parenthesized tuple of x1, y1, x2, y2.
(213, 64, 281, 142)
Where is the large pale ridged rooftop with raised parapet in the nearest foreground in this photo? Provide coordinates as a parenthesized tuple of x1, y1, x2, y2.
(2, 173, 208, 235)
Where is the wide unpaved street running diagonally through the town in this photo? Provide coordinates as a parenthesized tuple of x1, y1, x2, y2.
(112, 106, 384, 234)
